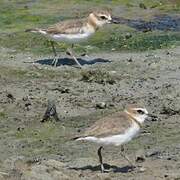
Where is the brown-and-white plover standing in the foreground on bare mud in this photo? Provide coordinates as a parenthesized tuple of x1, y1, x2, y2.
(74, 105, 154, 172)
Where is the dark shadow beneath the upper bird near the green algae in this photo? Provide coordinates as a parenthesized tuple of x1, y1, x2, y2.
(34, 58, 111, 66)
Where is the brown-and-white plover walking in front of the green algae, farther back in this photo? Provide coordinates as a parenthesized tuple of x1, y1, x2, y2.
(26, 10, 117, 68)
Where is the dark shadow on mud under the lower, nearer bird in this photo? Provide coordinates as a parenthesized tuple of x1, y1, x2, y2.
(69, 164, 135, 173)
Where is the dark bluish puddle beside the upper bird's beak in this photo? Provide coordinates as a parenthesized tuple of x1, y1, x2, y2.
(114, 15, 180, 32)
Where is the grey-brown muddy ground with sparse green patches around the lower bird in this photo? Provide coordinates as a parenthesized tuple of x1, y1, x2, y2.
(0, 47, 180, 180)
